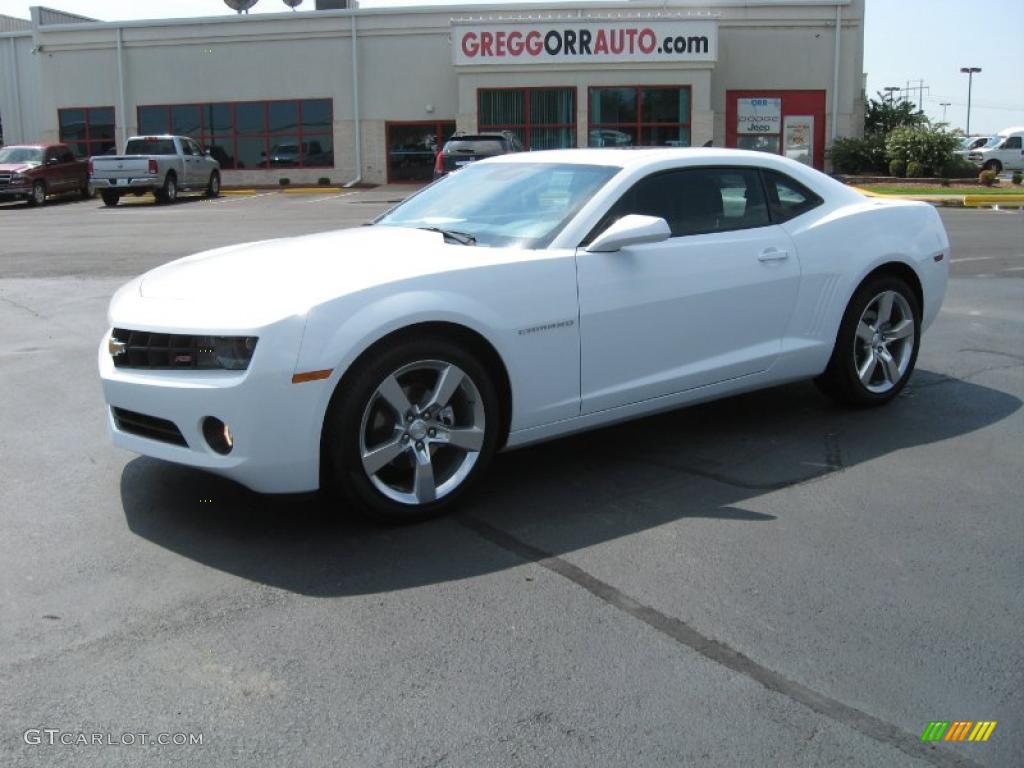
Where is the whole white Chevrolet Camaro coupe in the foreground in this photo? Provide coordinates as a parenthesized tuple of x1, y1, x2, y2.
(99, 148, 949, 520)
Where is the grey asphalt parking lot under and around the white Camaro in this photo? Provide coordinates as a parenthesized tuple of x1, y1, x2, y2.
(0, 187, 1024, 768)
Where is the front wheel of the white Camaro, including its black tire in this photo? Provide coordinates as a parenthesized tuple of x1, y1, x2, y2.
(324, 337, 501, 523)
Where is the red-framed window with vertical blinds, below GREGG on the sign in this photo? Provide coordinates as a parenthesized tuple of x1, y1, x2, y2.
(477, 88, 575, 150)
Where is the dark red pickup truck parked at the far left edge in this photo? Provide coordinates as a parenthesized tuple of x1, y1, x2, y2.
(0, 144, 91, 206)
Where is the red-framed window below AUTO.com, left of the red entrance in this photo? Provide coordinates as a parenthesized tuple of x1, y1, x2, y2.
(587, 85, 690, 146)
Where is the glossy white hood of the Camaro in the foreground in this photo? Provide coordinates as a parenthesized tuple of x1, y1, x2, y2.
(119, 226, 514, 328)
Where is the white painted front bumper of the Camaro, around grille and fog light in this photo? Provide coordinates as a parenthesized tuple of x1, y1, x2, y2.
(98, 318, 330, 494)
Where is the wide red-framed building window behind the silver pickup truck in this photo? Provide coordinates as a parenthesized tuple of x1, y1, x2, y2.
(138, 98, 334, 170)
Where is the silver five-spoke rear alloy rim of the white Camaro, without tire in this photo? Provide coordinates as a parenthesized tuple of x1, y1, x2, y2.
(853, 291, 915, 394)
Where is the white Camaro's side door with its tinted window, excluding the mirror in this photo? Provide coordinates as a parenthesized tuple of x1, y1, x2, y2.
(578, 167, 800, 414)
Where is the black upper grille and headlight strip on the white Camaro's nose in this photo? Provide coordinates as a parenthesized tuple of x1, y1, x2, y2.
(106, 328, 258, 371)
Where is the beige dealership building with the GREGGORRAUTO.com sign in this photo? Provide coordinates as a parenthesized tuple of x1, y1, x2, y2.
(0, 0, 864, 184)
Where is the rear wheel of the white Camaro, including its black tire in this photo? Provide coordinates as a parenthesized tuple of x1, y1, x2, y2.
(815, 275, 921, 408)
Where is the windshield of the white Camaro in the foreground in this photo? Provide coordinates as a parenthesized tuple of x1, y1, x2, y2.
(375, 163, 620, 248)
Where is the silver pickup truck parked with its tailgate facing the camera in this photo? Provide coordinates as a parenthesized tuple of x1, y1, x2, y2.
(89, 136, 220, 207)
